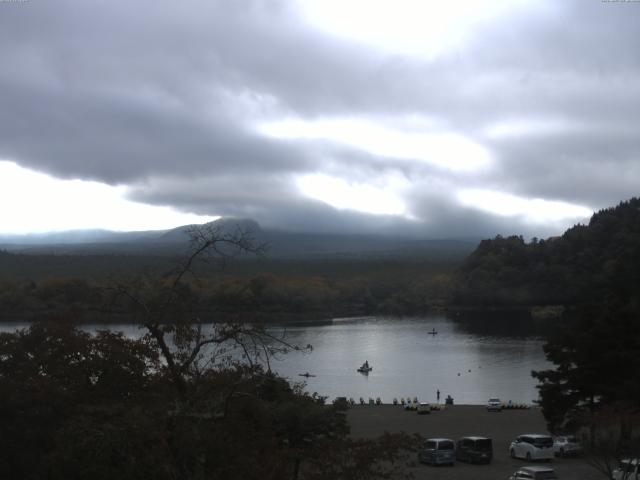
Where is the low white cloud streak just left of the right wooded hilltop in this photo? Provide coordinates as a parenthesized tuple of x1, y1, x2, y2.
(458, 189, 593, 224)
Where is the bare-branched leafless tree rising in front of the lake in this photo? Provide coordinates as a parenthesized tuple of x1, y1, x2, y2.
(114, 222, 311, 396)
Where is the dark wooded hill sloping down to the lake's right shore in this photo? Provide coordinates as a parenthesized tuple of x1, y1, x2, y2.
(454, 198, 640, 306)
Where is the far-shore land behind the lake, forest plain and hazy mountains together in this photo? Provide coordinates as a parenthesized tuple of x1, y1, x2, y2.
(0, 220, 476, 322)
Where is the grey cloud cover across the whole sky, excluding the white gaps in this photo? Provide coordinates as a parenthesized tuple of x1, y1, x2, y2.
(0, 0, 640, 237)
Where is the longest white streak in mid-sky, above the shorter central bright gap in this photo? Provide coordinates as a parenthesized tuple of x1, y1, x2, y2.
(258, 119, 491, 171)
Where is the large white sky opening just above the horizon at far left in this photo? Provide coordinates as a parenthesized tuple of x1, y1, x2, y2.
(0, 161, 217, 233)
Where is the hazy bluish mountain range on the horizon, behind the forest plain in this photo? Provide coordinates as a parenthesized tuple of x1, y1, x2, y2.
(0, 218, 477, 261)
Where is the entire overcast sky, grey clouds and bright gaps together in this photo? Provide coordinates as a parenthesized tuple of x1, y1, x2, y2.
(0, 0, 640, 238)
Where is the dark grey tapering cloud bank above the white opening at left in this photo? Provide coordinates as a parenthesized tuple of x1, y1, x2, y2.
(0, 80, 316, 183)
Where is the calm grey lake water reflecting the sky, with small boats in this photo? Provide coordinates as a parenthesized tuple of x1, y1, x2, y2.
(0, 315, 550, 404)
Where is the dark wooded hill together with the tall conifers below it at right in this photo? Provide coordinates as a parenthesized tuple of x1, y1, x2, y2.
(444, 198, 640, 464)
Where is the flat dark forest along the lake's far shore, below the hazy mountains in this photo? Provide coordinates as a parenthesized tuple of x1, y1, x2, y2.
(0, 252, 455, 322)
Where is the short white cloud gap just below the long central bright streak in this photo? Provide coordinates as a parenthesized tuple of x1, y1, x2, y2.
(297, 173, 410, 218)
